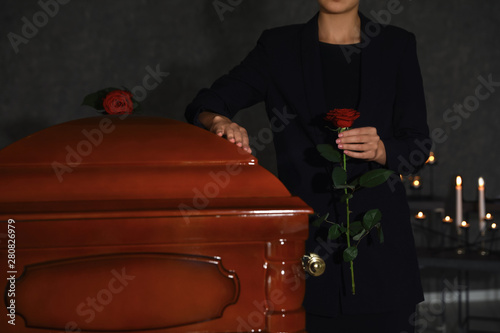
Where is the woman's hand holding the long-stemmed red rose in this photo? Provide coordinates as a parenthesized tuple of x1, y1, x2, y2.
(335, 127, 387, 165)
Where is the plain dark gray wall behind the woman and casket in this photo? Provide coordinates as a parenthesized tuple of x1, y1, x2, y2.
(0, 0, 500, 200)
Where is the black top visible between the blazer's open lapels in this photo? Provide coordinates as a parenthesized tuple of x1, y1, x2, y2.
(319, 42, 361, 111)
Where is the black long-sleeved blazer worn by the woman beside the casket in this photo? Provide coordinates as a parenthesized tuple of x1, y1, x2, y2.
(186, 14, 431, 316)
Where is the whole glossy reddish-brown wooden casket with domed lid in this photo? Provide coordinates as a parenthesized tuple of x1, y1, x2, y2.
(0, 116, 312, 333)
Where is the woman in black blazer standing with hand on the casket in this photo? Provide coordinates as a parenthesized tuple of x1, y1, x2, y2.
(186, 0, 430, 333)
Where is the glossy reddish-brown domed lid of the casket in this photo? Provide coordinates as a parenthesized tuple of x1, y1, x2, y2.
(0, 116, 309, 218)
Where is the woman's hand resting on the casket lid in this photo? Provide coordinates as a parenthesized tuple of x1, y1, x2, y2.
(198, 111, 252, 154)
